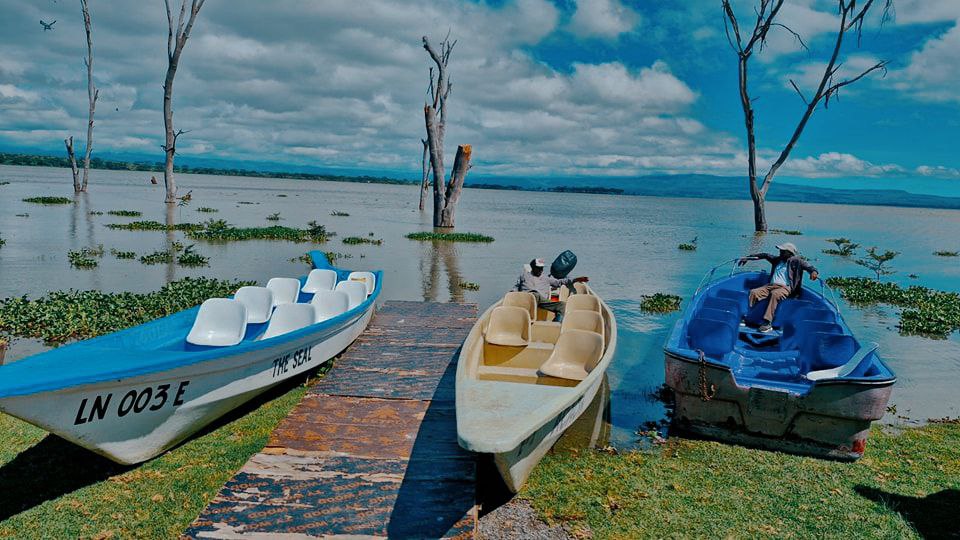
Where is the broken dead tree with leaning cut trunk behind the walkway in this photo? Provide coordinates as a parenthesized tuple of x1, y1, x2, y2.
(420, 33, 472, 228)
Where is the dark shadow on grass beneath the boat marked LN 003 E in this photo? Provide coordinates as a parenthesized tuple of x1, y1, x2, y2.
(0, 366, 328, 521)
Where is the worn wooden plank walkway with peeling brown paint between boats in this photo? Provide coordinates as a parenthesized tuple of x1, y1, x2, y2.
(184, 302, 477, 538)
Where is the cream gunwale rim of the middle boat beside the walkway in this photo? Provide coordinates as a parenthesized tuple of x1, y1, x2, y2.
(455, 285, 617, 454)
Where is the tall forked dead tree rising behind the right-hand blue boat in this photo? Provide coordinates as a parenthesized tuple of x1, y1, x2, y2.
(721, 0, 893, 232)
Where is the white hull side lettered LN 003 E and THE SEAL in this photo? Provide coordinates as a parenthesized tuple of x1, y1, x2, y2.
(0, 302, 375, 464)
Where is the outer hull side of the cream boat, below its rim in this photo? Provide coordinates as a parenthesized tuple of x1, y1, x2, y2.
(493, 372, 603, 493)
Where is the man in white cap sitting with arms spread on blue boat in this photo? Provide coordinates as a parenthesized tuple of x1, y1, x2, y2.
(737, 242, 820, 332)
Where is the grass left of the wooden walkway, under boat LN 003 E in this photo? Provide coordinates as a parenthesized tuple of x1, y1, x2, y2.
(0, 381, 305, 538)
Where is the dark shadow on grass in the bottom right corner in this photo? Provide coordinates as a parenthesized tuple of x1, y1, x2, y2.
(854, 486, 960, 538)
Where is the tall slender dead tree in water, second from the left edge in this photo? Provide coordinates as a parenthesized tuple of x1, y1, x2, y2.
(163, 0, 204, 204)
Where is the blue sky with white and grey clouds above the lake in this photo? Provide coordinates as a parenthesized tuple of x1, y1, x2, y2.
(0, 0, 960, 182)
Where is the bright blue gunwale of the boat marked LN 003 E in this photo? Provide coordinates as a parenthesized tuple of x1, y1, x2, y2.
(0, 252, 383, 400)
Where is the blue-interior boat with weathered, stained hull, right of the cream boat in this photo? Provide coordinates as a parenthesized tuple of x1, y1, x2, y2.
(664, 267, 896, 460)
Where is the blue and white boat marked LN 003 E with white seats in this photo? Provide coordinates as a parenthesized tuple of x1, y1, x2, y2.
(0, 251, 383, 464)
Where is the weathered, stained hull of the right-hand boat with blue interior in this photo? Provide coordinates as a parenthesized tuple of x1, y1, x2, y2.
(665, 352, 894, 461)
